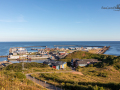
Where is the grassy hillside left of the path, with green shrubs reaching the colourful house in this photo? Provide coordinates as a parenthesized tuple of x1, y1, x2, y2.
(0, 62, 52, 90)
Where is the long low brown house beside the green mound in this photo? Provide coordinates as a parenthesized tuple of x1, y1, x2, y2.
(71, 59, 101, 67)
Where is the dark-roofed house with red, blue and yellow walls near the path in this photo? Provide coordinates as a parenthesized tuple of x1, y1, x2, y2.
(43, 60, 67, 70)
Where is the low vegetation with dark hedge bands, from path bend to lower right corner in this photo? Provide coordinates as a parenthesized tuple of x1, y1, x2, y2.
(32, 73, 120, 90)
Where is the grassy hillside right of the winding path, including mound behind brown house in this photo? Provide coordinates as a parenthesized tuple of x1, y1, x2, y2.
(29, 51, 120, 90)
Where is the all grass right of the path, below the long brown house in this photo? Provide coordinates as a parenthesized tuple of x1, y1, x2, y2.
(32, 63, 120, 90)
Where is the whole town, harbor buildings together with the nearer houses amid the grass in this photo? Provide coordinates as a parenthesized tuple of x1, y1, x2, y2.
(0, 46, 109, 70)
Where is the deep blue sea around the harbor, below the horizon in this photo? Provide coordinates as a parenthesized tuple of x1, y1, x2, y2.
(0, 41, 120, 63)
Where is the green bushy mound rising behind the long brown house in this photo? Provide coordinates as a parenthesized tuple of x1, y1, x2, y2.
(60, 51, 120, 69)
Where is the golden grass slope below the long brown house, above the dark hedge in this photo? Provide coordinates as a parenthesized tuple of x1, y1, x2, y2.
(77, 66, 120, 84)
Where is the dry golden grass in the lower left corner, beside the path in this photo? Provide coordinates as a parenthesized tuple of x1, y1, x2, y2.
(0, 70, 46, 90)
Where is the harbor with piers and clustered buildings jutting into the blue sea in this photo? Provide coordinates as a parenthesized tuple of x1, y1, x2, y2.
(0, 45, 110, 61)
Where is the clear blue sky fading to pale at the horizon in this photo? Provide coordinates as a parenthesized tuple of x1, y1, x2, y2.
(0, 0, 120, 42)
